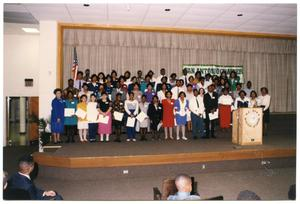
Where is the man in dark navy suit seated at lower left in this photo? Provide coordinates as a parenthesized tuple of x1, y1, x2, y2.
(8, 156, 63, 200)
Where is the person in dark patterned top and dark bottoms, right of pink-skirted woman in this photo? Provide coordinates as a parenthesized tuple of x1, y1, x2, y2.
(112, 93, 125, 142)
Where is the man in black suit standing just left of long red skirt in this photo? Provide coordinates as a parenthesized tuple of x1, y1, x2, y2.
(203, 84, 218, 138)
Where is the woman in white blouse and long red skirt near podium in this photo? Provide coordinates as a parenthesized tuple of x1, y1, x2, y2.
(218, 88, 233, 130)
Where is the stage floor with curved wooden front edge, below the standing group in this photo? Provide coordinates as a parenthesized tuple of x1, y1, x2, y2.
(34, 113, 296, 168)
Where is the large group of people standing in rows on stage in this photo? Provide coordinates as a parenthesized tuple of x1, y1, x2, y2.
(51, 68, 270, 143)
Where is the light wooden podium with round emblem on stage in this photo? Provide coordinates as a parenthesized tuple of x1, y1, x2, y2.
(232, 108, 263, 145)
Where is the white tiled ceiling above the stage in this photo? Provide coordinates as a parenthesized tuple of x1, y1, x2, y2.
(4, 3, 297, 35)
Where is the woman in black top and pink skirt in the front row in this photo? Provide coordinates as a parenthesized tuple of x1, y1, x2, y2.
(97, 92, 112, 142)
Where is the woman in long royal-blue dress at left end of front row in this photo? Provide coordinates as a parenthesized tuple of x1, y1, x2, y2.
(51, 89, 65, 144)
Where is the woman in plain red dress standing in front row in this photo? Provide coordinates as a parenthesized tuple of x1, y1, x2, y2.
(162, 91, 175, 140)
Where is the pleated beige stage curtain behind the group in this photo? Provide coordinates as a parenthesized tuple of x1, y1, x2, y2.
(63, 29, 297, 112)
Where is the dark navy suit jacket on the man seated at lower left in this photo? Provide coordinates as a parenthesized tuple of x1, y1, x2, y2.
(8, 173, 44, 200)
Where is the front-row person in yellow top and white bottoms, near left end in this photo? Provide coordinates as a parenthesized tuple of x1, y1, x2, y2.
(77, 95, 89, 142)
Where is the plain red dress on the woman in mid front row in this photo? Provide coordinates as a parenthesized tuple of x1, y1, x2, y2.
(162, 99, 175, 127)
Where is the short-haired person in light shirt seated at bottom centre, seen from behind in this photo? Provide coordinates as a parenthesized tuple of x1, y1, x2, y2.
(168, 174, 200, 200)
